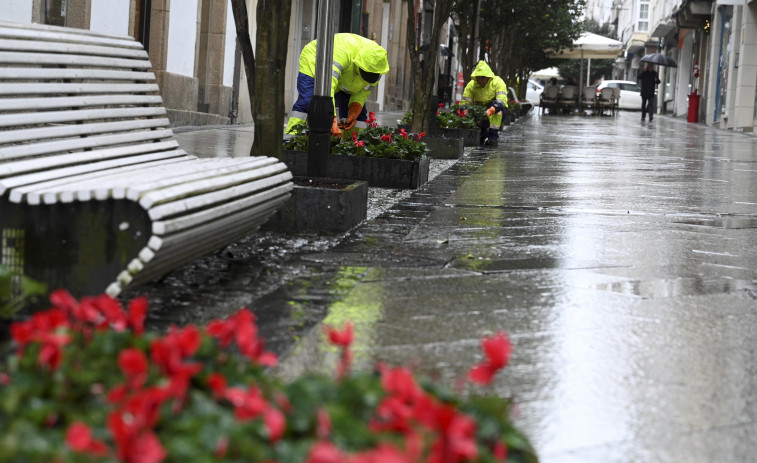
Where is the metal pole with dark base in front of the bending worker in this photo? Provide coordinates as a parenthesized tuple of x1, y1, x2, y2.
(308, 0, 334, 177)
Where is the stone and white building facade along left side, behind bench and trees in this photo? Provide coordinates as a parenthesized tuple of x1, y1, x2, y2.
(5, 0, 458, 126)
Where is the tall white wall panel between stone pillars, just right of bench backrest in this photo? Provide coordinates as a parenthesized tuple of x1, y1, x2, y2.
(167, 0, 198, 77)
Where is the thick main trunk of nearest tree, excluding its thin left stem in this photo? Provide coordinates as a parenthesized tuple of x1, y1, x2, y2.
(252, 0, 292, 159)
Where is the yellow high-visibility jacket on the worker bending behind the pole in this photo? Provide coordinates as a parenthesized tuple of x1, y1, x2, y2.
(300, 33, 389, 114)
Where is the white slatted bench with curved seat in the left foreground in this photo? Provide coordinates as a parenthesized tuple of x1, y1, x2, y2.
(0, 22, 293, 296)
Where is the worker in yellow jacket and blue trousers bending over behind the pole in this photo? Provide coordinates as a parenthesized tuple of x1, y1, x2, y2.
(285, 33, 389, 137)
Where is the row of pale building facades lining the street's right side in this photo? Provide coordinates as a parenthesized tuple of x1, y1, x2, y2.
(610, 0, 757, 132)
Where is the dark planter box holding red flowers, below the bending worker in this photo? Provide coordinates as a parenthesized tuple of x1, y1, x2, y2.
(284, 150, 430, 189)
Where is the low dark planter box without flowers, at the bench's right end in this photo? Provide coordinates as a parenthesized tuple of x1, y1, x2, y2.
(263, 177, 368, 233)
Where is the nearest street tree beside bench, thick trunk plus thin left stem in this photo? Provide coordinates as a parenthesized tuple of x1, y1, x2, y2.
(231, 0, 292, 159)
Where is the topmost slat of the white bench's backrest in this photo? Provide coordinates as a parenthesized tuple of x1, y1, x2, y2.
(0, 21, 142, 49)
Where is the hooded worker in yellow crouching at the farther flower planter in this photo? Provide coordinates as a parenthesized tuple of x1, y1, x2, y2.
(461, 61, 507, 145)
